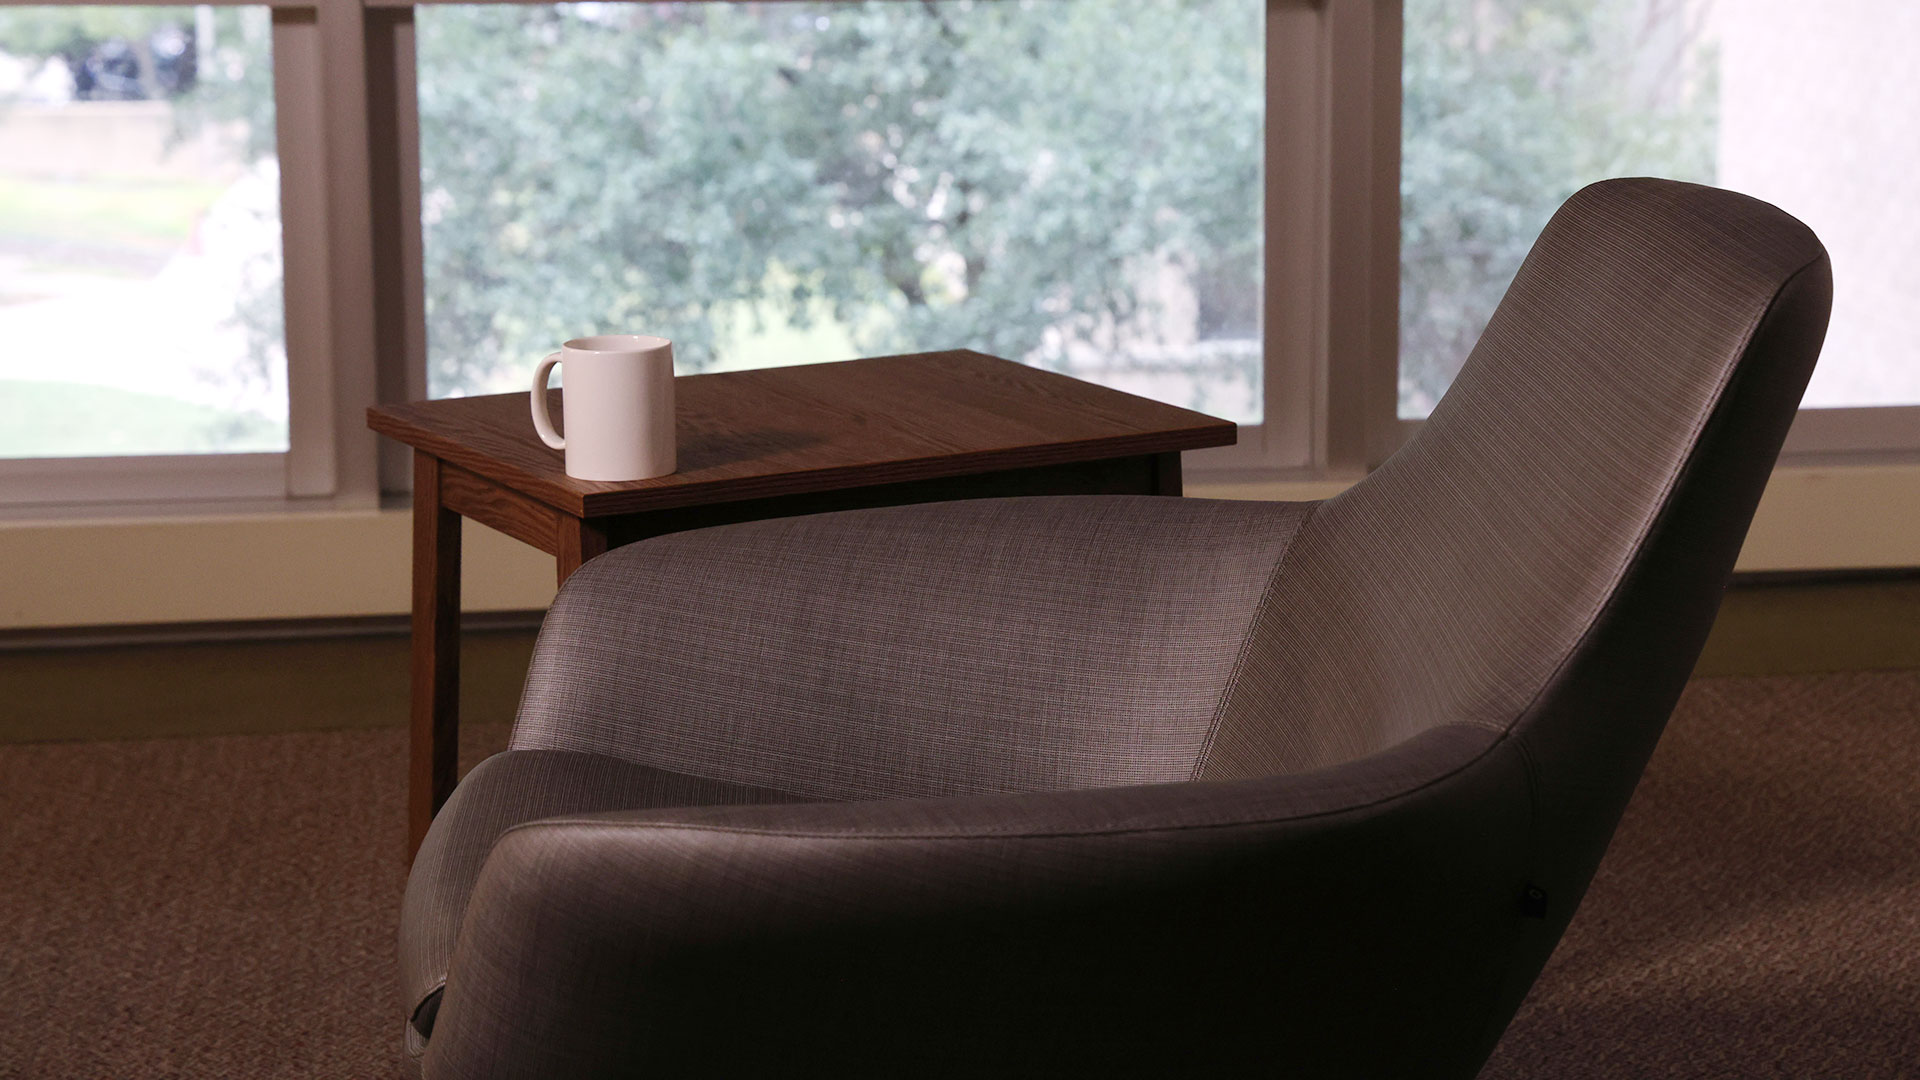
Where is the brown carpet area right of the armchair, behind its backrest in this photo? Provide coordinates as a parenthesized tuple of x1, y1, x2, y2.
(1480, 673, 1920, 1080)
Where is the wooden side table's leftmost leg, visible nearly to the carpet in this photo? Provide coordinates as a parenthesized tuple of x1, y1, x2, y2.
(407, 450, 461, 861)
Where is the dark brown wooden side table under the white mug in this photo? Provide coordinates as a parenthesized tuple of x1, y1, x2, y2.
(367, 352, 1235, 853)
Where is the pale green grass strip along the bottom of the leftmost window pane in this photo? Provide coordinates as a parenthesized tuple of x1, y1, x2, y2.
(0, 380, 286, 457)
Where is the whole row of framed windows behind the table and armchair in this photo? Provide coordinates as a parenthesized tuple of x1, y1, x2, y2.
(0, 0, 1920, 505)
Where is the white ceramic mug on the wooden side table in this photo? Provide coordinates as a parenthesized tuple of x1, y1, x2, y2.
(532, 334, 676, 480)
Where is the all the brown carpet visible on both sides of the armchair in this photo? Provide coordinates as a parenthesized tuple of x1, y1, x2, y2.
(0, 673, 1920, 1080)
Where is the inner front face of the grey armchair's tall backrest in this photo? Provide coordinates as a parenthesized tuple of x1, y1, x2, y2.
(1200, 181, 1824, 778)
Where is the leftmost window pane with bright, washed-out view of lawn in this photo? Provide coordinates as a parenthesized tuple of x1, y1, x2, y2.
(0, 6, 286, 457)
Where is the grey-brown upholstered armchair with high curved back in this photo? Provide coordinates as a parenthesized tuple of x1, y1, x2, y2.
(401, 181, 1830, 1078)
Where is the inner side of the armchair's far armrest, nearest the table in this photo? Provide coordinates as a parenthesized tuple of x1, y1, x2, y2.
(513, 496, 1302, 799)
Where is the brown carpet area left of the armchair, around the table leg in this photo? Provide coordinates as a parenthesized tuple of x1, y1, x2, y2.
(0, 724, 507, 1080)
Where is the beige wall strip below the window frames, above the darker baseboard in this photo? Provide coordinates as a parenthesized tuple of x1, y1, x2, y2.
(0, 465, 1920, 628)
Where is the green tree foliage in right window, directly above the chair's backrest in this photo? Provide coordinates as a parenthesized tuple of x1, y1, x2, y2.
(1400, 0, 1718, 417)
